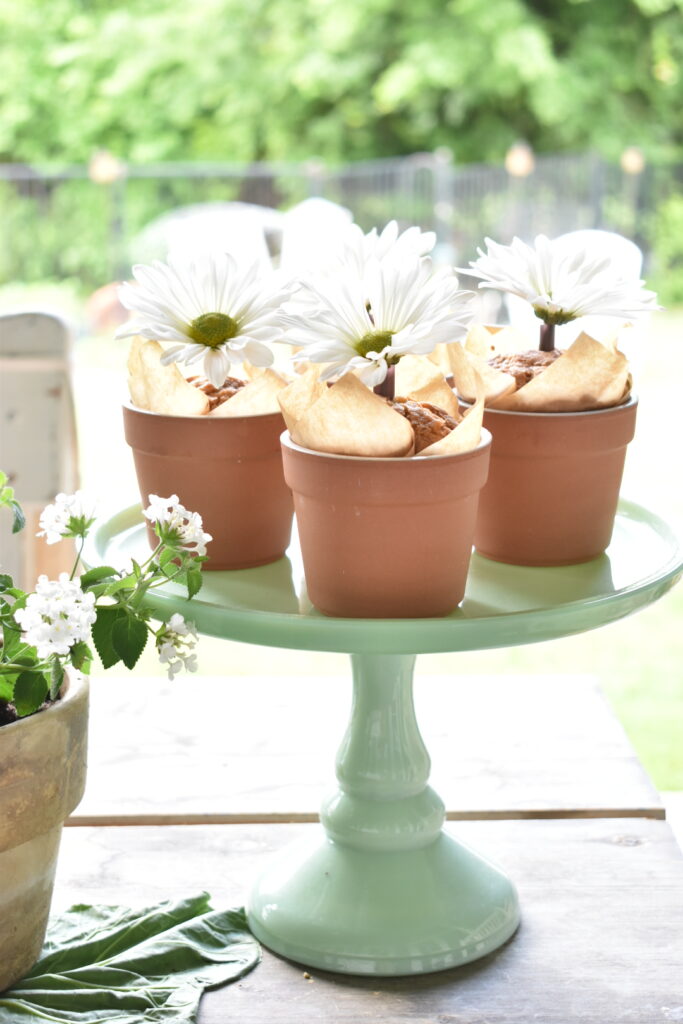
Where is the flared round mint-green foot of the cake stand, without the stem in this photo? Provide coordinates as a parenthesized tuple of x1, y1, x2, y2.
(249, 829, 519, 976)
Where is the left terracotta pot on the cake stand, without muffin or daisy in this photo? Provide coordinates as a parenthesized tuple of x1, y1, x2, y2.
(123, 403, 293, 569)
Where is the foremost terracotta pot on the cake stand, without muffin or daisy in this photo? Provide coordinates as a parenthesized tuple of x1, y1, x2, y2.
(282, 430, 490, 618)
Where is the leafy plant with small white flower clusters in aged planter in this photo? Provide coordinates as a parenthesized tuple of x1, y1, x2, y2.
(0, 473, 210, 991)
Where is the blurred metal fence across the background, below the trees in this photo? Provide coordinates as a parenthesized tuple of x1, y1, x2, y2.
(0, 150, 683, 301)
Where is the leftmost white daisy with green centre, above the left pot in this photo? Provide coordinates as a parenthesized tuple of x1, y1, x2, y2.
(116, 253, 289, 387)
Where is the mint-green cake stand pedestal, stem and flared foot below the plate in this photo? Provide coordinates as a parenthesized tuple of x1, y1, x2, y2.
(248, 654, 519, 975)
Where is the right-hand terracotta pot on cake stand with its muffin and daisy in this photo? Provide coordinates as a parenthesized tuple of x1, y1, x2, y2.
(452, 236, 657, 565)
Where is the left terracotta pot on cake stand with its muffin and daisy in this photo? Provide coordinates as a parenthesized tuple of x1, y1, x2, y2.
(117, 247, 293, 569)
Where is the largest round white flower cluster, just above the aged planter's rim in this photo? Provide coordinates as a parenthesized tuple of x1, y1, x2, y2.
(14, 572, 96, 658)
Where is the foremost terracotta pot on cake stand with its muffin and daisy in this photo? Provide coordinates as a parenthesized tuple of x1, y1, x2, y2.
(281, 228, 489, 617)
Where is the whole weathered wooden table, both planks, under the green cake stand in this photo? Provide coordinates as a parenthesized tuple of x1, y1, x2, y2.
(54, 676, 683, 1024)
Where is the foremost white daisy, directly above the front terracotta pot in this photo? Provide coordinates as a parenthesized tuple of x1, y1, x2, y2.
(285, 256, 472, 387)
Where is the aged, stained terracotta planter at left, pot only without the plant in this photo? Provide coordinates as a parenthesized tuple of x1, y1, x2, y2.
(0, 677, 88, 991)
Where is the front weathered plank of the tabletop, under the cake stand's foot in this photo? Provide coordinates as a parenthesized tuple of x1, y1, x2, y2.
(55, 818, 683, 1024)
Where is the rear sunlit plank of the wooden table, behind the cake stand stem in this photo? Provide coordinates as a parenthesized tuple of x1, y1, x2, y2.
(72, 670, 664, 824)
